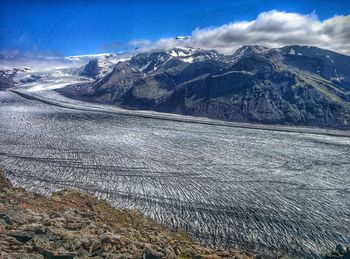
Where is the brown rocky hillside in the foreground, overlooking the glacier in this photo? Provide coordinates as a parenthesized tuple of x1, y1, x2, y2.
(0, 172, 254, 259)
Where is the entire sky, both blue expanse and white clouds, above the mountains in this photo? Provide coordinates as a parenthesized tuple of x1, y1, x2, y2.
(0, 0, 350, 56)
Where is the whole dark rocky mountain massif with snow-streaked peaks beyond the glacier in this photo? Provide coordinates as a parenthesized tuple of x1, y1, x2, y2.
(62, 46, 350, 128)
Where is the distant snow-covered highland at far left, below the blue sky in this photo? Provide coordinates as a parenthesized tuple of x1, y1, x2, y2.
(0, 53, 130, 89)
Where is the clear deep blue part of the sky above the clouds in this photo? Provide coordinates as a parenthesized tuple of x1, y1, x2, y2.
(0, 0, 350, 55)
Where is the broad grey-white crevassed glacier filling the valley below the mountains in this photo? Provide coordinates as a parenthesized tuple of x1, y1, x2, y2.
(0, 85, 350, 257)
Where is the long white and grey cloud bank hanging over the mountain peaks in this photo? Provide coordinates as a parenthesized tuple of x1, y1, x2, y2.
(129, 10, 350, 55)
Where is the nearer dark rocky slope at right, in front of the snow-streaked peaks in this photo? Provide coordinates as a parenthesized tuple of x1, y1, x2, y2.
(159, 54, 350, 126)
